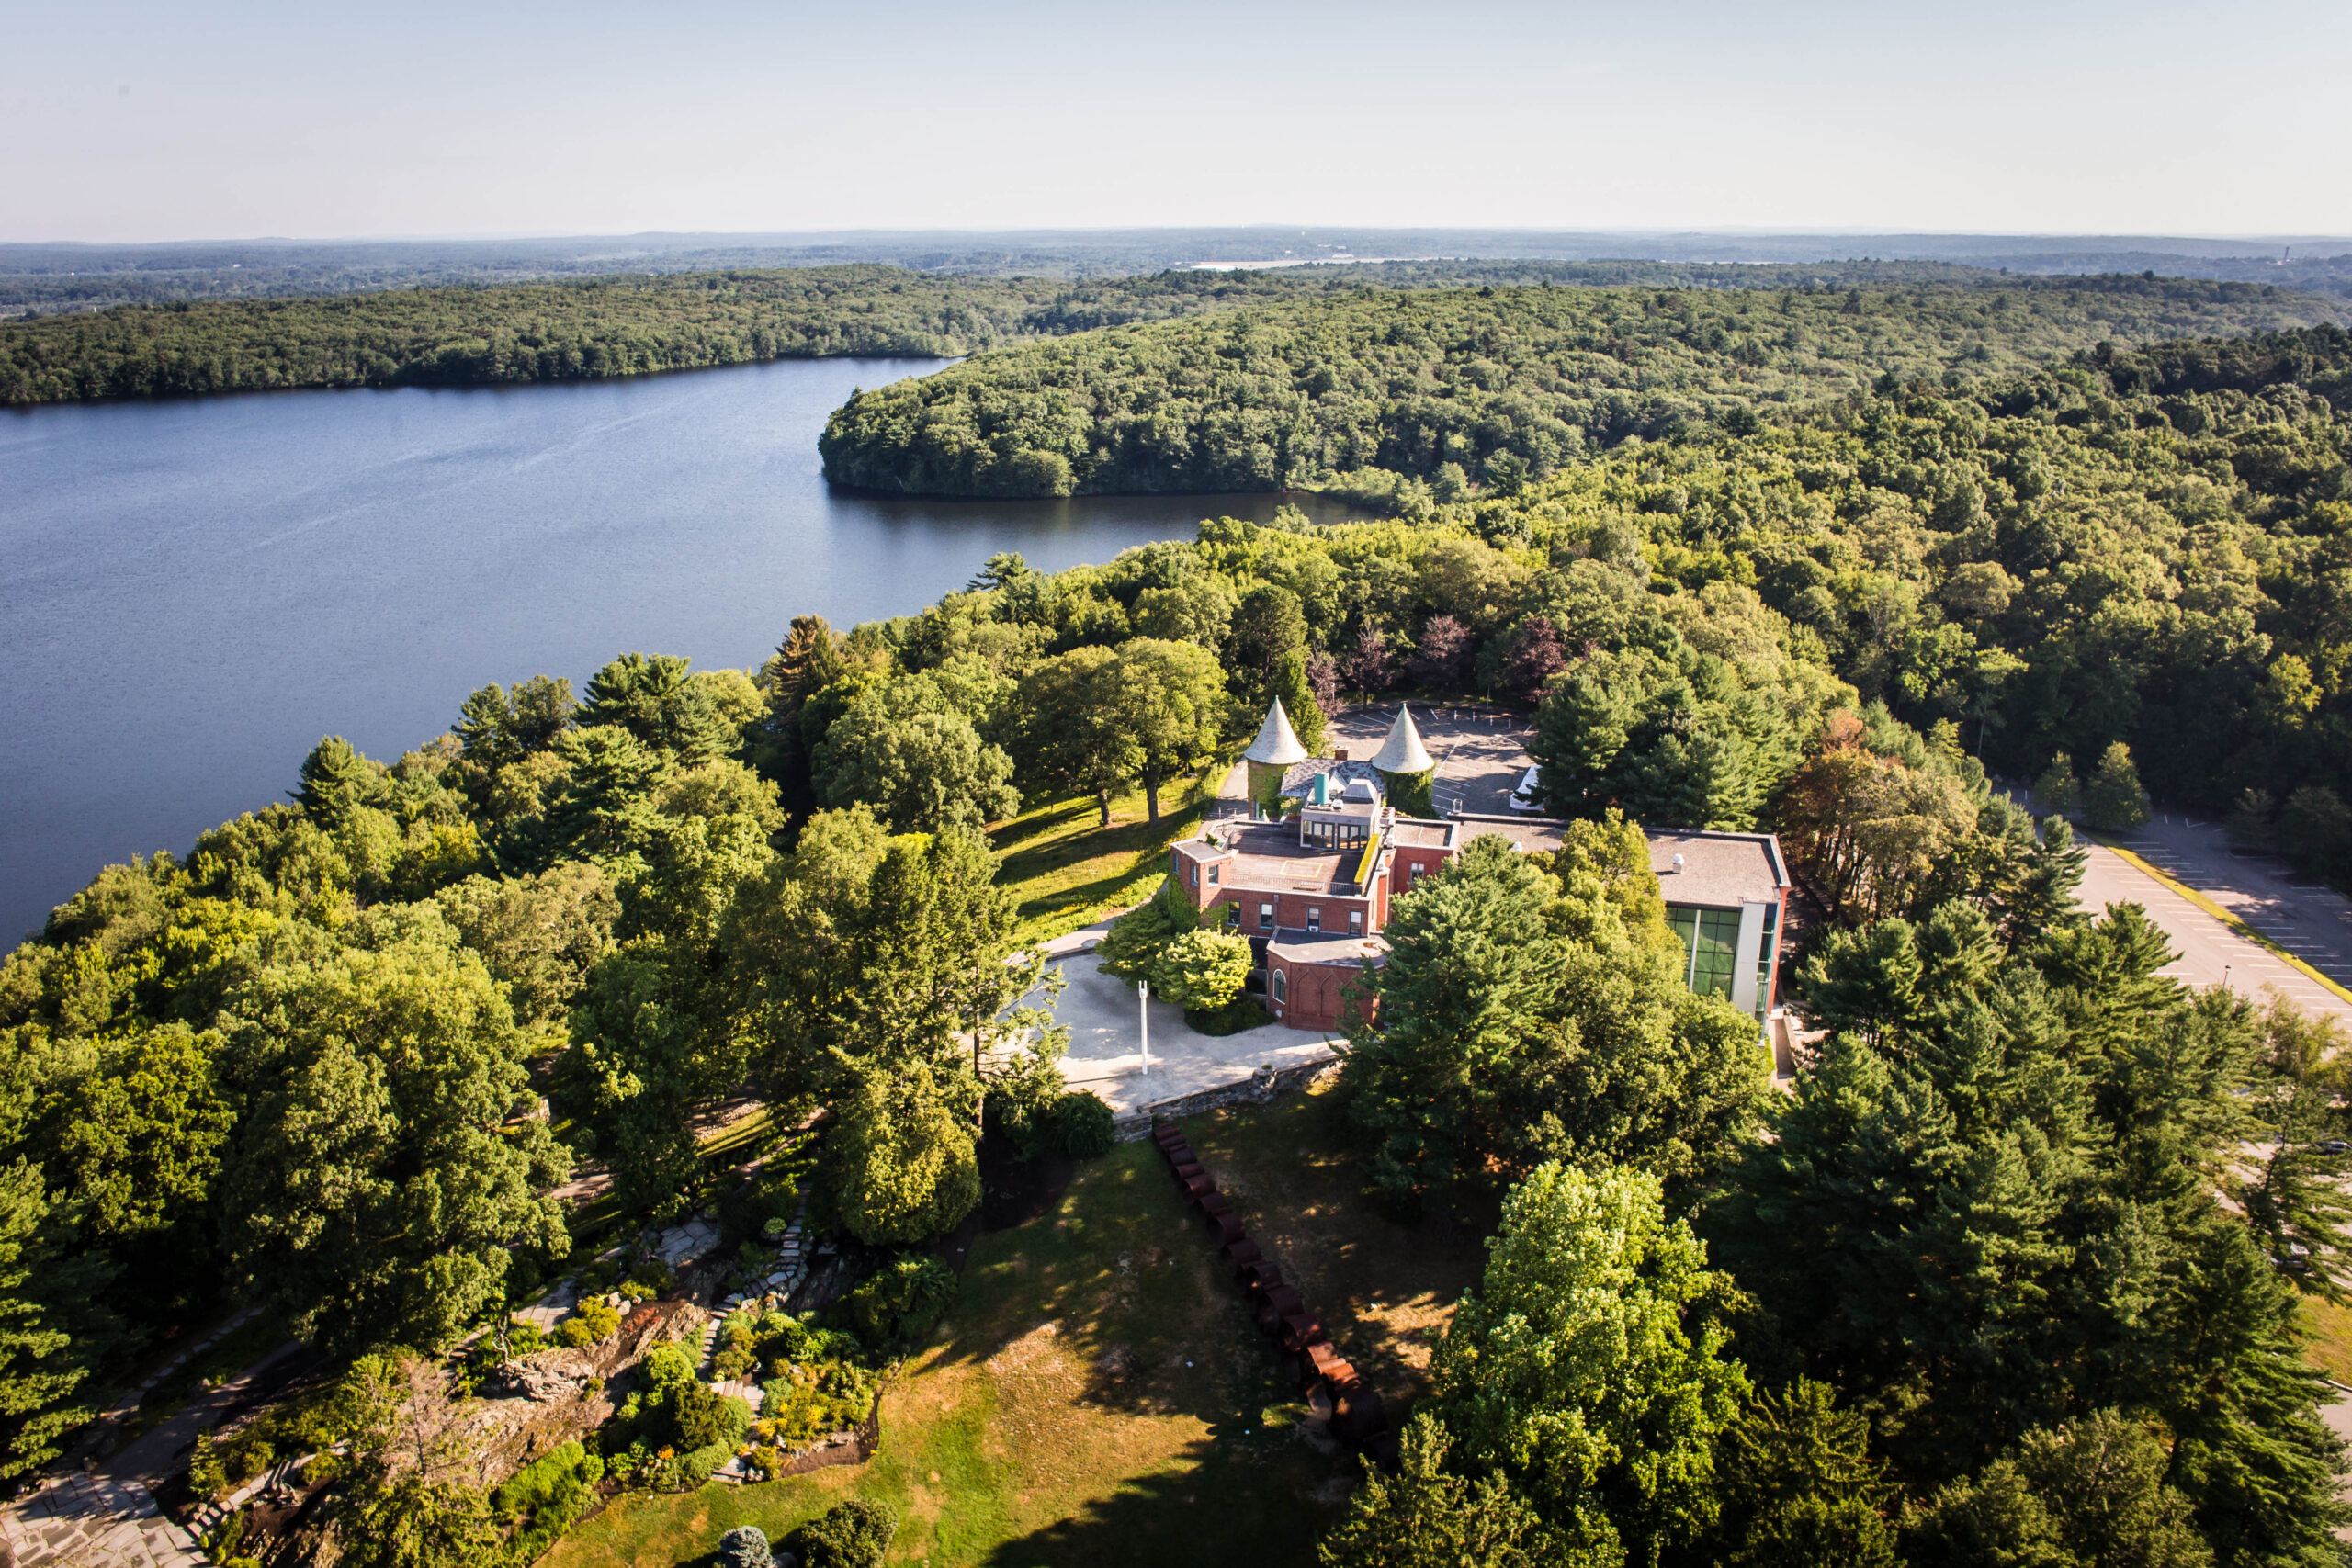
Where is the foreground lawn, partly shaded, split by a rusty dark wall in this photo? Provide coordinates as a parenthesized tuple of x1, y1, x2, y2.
(546, 1096, 1479, 1568)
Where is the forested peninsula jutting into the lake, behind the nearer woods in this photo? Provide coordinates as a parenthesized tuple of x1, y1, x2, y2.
(823, 275, 2334, 503)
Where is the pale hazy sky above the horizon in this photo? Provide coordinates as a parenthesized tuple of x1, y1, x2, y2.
(0, 0, 2352, 240)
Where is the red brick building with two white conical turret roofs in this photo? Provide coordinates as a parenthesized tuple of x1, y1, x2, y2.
(1169, 707, 1790, 1039)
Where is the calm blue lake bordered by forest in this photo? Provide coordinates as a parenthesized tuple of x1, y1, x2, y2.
(0, 360, 1345, 950)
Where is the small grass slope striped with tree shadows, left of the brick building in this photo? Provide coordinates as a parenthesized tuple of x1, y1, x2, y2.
(988, 764, 1227, 942)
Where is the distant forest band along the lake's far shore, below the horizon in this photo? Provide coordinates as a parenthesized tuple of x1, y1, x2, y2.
(0, 261, 2328, 404)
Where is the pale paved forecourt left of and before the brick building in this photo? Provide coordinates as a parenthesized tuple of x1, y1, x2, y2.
(1030, 926, 1329, 1110)
